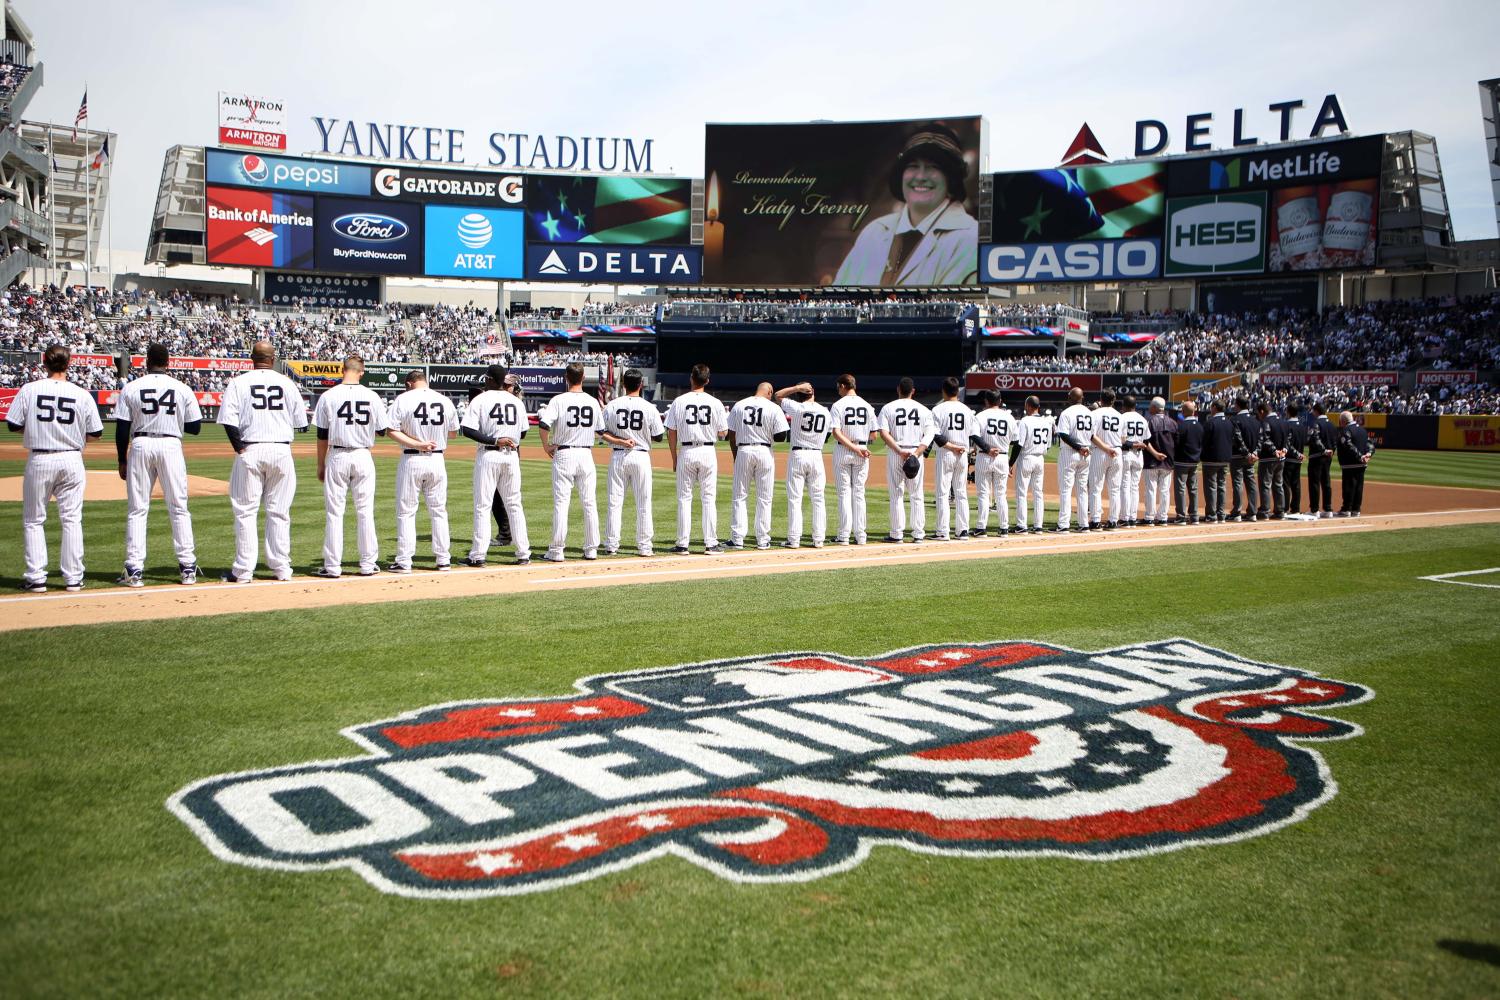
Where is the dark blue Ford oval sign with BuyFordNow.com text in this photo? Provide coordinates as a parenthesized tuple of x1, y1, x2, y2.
(314, 198, 422, 274)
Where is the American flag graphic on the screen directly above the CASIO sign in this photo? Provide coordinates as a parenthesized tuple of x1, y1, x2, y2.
(992, 163, 1166, 243)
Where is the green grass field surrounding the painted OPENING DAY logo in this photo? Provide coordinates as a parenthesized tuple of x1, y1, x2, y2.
(0, 434, 1500, 997)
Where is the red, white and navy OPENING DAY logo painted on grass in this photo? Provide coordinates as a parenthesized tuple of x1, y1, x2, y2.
(167, 639, 1373, 898)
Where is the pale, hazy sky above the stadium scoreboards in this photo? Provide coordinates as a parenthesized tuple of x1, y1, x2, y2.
(15, 0, 1500, 249)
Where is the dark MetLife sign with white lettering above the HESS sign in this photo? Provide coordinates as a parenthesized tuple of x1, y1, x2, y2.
(1167, 135, 1386, 195)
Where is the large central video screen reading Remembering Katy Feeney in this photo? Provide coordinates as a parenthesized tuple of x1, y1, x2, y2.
(704, 117, 986, 286)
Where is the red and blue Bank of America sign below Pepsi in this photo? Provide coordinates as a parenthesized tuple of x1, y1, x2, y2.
(206, 186, 314, 268)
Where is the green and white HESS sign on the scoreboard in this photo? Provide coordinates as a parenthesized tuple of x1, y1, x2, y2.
(1163, 190, 1266, 277)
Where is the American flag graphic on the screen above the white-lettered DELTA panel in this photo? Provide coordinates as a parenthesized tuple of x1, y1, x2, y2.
(527, 175, 693, 246)
